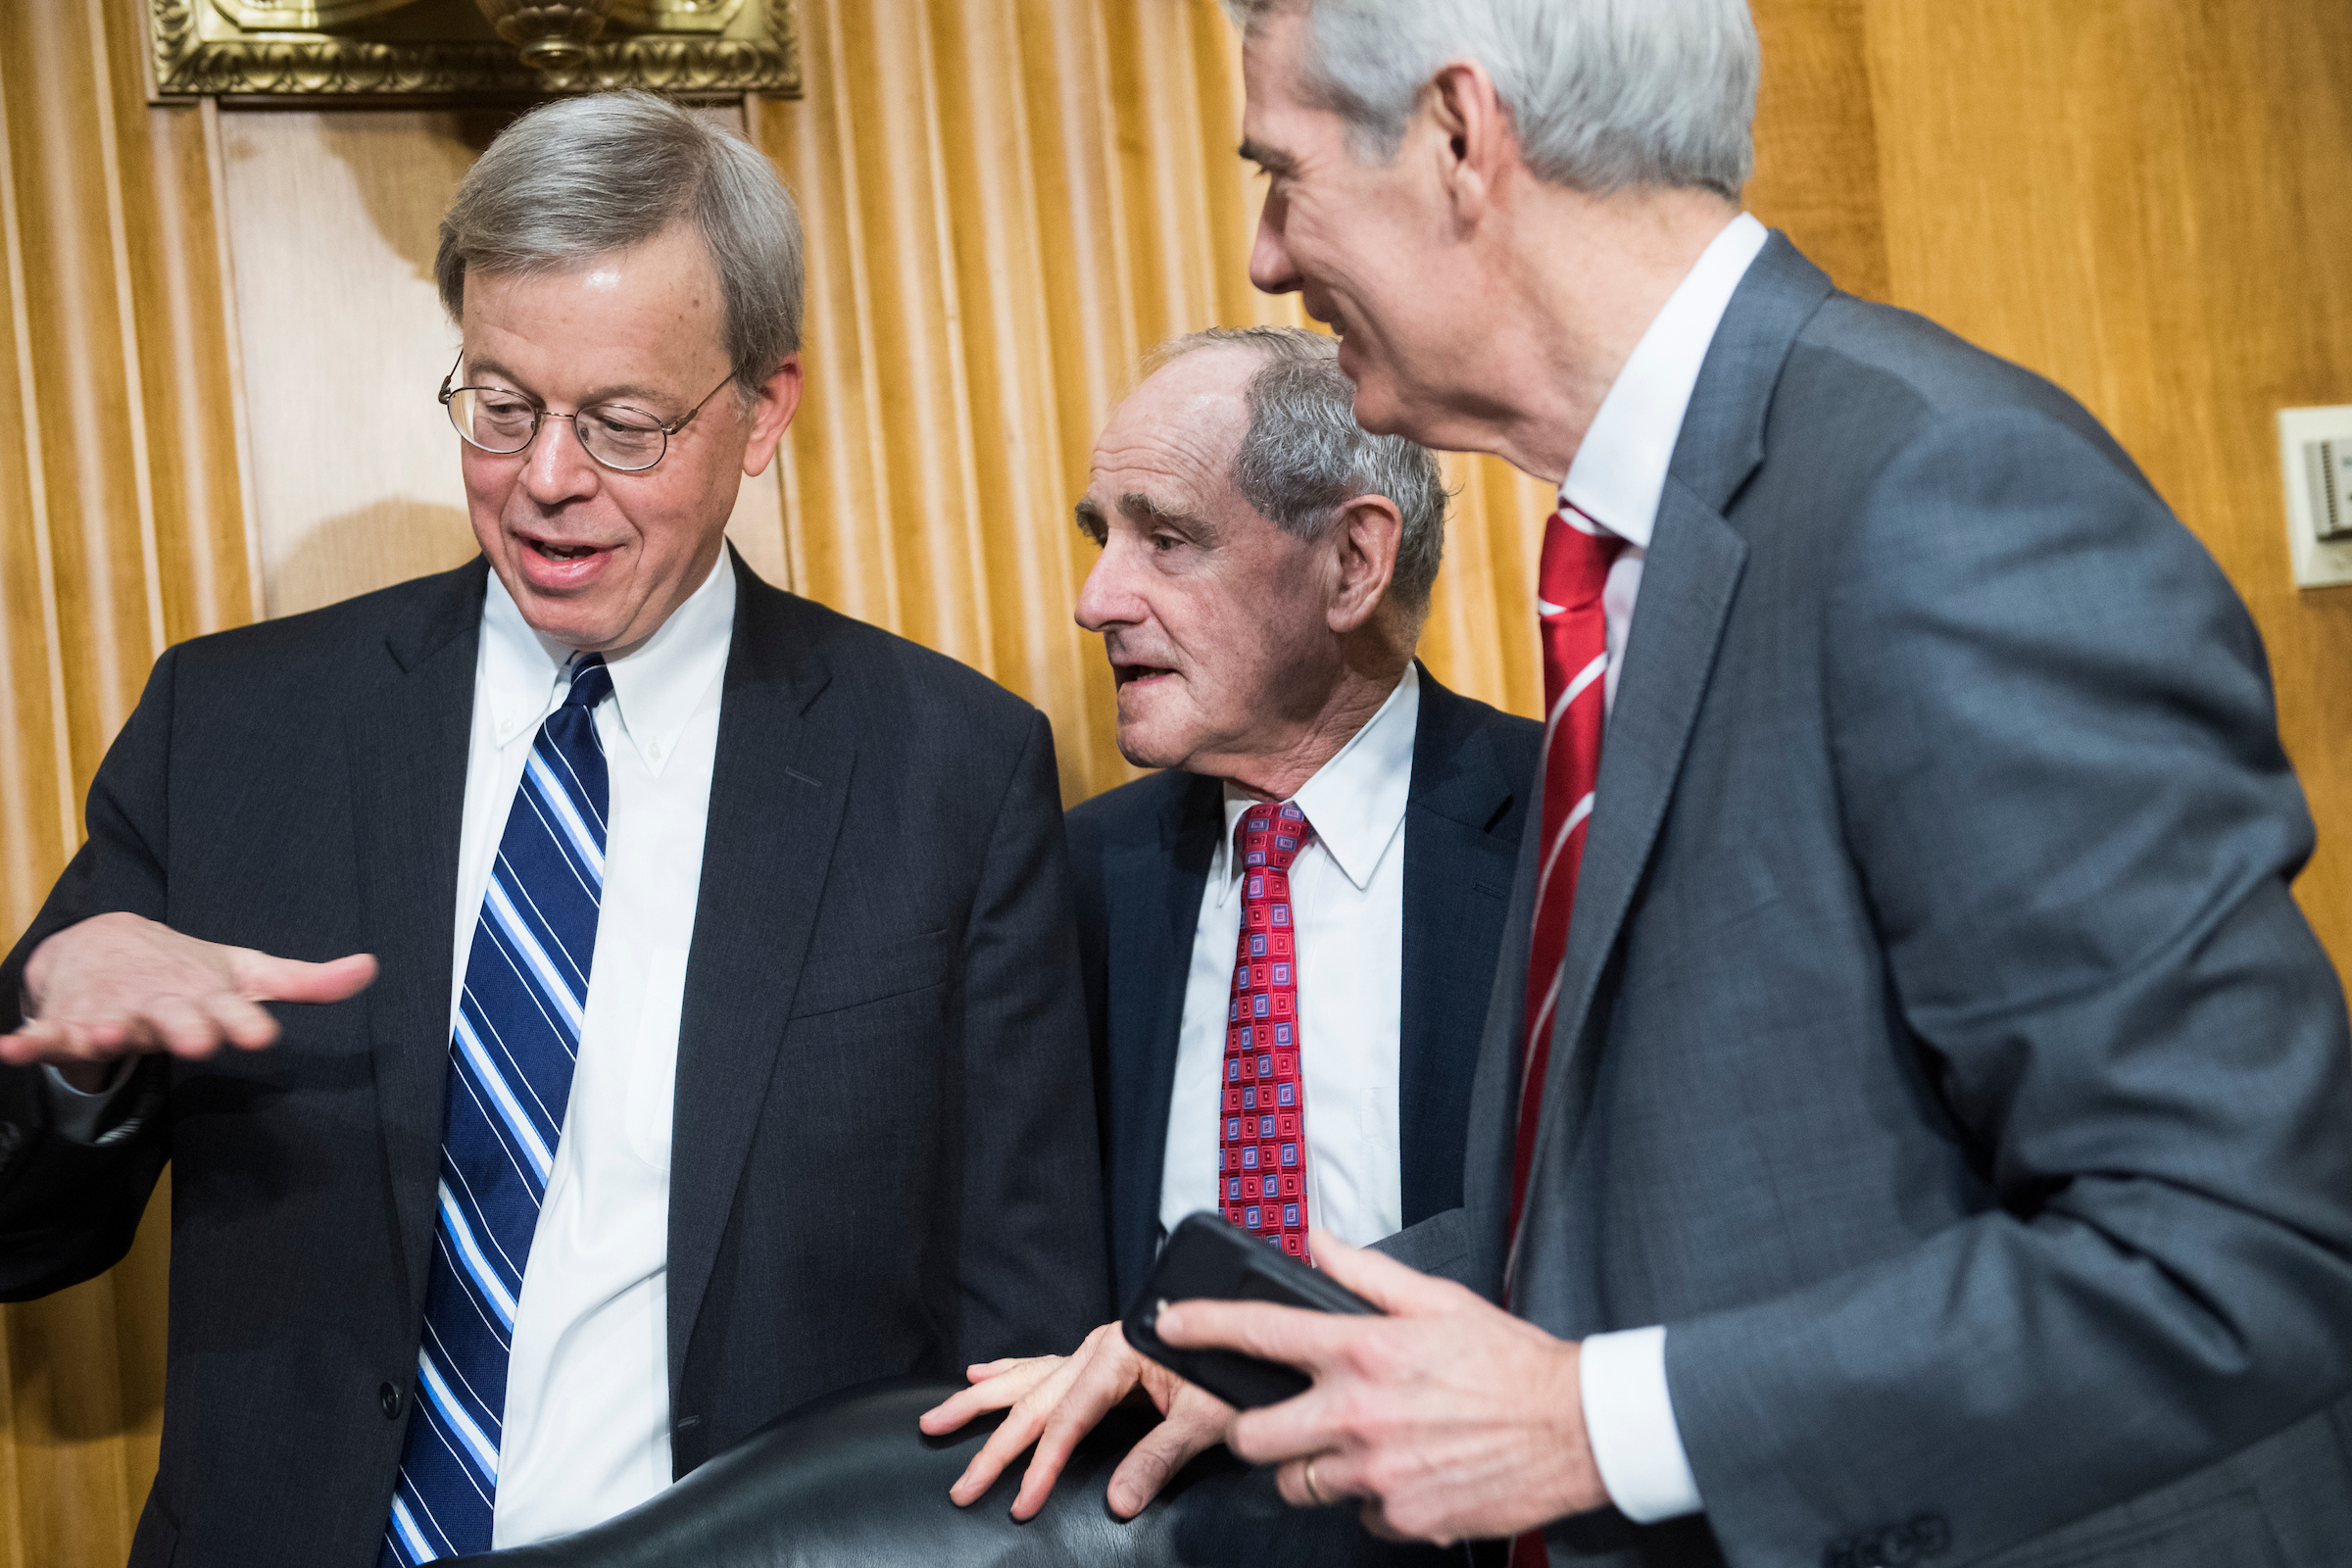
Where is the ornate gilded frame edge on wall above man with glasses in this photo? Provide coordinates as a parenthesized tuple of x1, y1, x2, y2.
(148, 0, 800, 101)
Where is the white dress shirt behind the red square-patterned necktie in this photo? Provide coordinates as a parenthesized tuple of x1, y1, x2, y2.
(1159, 665, 1421, 1246)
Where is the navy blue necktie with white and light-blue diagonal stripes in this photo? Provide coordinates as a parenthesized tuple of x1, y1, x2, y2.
(378, 654, 612, 1568)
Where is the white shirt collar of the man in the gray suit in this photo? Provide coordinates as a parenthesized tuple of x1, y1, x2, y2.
(1559, 212, 1771, 550)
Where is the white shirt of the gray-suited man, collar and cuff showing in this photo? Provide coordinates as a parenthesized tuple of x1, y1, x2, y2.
(1559, 212, 1771, 1523)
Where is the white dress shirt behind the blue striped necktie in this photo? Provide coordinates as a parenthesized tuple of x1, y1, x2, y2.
(449, 550, 736, 1546)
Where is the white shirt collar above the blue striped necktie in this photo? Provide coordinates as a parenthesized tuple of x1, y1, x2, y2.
(477, 546, 736, 778)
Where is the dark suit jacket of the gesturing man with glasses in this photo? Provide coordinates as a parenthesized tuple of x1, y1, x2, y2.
(0, 560, 1107, 1568)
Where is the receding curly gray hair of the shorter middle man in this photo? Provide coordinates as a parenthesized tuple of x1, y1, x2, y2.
(1151, 326, 1446, 615)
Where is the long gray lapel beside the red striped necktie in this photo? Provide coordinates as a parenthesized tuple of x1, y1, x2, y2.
(1512, 232, 1833, 1259)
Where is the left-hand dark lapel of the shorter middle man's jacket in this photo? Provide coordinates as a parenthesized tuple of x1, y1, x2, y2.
(1103, 776, 1223, 1298)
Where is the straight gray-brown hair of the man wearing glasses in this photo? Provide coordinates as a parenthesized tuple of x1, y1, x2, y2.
(433, 92, 802, 395)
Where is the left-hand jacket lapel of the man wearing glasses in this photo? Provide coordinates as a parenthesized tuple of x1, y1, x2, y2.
(346, 560, 489, 1314)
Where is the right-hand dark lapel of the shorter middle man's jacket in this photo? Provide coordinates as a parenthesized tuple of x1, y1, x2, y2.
(1397, 670, 1524, 1225)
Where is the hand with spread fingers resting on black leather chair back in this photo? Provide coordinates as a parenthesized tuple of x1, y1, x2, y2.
(919, 1324, 1233, 1519)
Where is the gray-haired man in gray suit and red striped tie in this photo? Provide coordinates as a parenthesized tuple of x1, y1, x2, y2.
(1159, 0, 2352, 1568)
